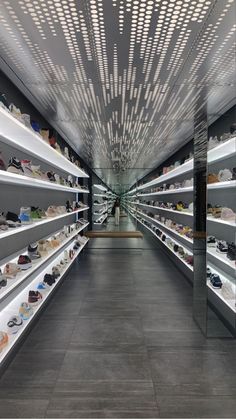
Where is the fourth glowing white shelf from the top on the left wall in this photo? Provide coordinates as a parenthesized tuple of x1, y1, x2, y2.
(0, 223, 89, 302)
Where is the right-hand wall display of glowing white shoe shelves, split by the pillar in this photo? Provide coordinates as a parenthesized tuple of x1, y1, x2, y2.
(122, 137, 236, 330)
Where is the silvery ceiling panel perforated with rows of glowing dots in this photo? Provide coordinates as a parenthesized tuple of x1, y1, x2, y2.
(0, 0, 236, 189)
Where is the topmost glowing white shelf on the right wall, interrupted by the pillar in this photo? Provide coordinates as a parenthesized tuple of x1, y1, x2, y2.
(137, 137, 236, 192)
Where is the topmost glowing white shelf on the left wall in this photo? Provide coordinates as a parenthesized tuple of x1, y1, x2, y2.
(0, 107, 89, 178)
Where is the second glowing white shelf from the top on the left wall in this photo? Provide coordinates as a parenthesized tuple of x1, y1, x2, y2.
(0, 169, 89, 194)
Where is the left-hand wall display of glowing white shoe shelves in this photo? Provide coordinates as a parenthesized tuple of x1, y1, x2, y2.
(0, 108, 89, 368)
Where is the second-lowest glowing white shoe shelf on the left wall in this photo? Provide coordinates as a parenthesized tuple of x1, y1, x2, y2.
(0, 223, 89, 303)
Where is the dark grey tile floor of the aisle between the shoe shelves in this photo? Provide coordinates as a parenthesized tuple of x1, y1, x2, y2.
(0, 223, 236, 418)
